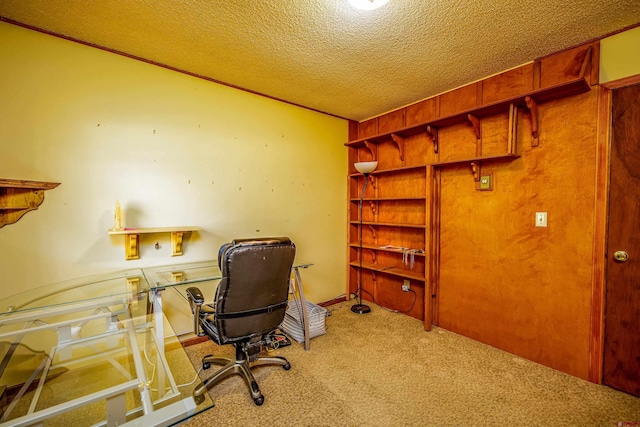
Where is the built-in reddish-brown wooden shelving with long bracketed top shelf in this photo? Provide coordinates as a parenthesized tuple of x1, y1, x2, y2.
(345, 47, 592, 329)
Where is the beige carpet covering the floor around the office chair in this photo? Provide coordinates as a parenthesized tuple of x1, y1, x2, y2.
(179, 303, 640, 427)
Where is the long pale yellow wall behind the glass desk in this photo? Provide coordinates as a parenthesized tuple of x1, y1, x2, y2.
(0, 22, 348, 334)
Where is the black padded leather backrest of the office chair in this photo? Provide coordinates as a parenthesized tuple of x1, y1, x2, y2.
(214, 237, 296, 344)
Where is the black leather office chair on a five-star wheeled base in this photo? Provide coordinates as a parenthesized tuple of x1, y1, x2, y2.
(187, 237, 296, 405)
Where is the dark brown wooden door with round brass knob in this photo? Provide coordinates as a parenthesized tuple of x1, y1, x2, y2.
(603, 85, 640, 396)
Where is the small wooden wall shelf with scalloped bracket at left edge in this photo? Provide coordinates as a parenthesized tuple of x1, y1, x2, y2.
(0, 179, 60, 228)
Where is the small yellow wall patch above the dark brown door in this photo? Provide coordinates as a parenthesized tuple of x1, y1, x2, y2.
(600, 27, 640, 84)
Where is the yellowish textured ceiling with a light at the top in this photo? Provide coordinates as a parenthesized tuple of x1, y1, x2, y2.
(0, 0, 640, 120)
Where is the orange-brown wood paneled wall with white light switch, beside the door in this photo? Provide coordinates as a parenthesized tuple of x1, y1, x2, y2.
(357, 42, 600, 379)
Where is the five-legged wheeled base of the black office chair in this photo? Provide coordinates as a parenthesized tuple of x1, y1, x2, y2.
(193, 355, 291, 406)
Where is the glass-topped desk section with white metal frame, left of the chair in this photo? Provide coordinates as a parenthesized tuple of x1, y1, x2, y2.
(0, 269, 213, 427)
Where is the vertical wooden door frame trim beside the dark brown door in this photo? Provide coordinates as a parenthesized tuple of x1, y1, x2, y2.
(588, 86, 611, 384)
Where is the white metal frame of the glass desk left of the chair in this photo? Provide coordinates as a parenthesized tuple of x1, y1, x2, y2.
(0, 269, 213, 427)
